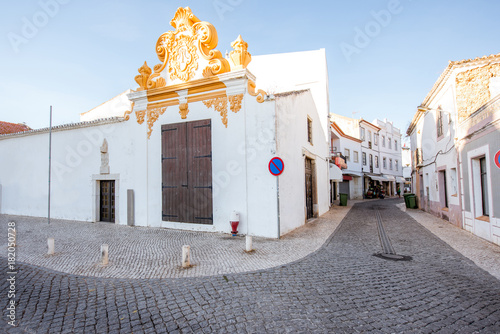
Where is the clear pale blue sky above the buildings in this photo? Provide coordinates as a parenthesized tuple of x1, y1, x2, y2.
(0, 0, 500, 138)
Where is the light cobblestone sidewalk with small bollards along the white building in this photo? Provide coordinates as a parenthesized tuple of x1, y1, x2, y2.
(0, 201, 355, 278)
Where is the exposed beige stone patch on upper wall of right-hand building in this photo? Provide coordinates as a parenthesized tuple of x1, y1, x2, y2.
(456, 63, 500, 121)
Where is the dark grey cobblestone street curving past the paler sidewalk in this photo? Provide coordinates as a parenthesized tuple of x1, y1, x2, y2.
(0, 200, 500, 333)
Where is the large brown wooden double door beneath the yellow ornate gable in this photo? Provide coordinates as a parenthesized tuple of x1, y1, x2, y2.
(161, 120, 213, 224)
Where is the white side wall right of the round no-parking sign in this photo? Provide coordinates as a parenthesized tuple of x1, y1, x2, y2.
(276, 91, 330, 235)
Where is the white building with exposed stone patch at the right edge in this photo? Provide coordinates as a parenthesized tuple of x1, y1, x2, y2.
(407, 55, 500, 244)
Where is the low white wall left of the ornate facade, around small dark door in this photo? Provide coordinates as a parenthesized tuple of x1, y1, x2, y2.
(0, 117, 143, 224)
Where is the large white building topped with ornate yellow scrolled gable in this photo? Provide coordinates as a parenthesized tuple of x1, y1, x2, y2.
(0, 7, 330, 238)
